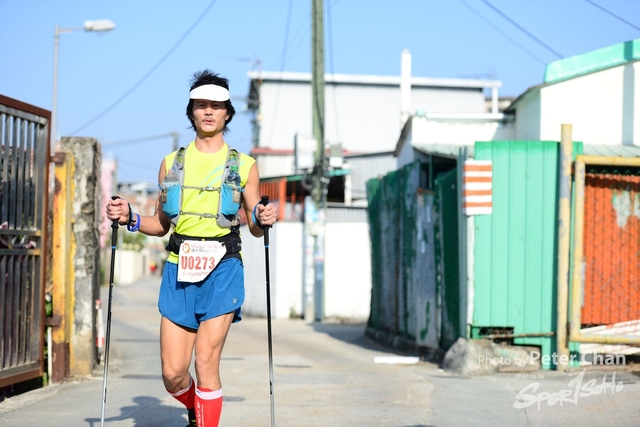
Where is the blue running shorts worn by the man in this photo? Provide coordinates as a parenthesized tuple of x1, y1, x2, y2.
(158, 258, 244, 329)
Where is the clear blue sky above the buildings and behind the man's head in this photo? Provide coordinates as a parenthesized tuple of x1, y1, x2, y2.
(0, 0, 640, 182)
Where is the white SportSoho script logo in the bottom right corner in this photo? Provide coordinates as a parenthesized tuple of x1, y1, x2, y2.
(513, 369, 624, 410)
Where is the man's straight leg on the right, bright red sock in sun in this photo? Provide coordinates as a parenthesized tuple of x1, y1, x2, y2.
(195, 313, 233, 427)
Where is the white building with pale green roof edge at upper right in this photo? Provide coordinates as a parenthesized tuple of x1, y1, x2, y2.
(505, 39, 640, 150)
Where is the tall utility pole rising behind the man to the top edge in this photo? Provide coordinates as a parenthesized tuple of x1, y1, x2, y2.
(311, 0, 327, 321)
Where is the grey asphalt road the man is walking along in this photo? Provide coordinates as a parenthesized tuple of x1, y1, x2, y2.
(0, 278, 640, 427)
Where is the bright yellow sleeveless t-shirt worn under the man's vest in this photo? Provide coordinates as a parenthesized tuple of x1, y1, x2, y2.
(165, 142, 256, 263)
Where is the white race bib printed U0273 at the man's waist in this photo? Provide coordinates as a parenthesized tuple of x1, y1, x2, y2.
(178, 240, 227, 283)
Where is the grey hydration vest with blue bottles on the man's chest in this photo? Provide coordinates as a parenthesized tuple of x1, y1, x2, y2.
(159, 147, 244, 228)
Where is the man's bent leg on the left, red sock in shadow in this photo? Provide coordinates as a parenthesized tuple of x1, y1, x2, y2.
(160, 317, 196, 422)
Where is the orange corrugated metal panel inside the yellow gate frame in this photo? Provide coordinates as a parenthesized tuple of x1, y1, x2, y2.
(581, 168, 640, 325)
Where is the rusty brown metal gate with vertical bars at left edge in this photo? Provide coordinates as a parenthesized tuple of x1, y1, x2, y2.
(0, 95, 51, 387)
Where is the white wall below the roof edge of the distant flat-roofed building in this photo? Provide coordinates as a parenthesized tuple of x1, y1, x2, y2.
(255, 81, 485, 154)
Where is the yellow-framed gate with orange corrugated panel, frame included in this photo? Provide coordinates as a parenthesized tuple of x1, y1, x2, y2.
(570, 155, 640, 345)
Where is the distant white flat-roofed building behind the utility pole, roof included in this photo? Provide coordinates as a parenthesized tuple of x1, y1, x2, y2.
(248, 51, 502, 203)
